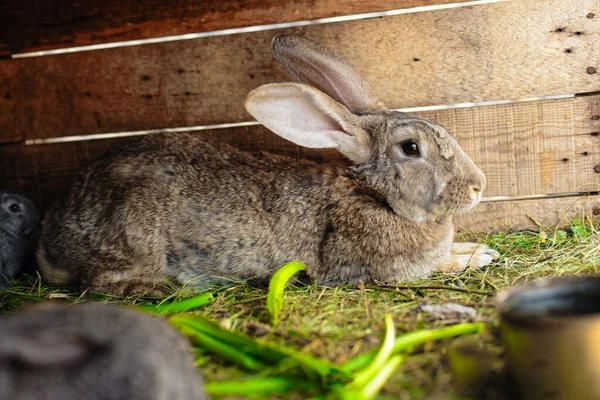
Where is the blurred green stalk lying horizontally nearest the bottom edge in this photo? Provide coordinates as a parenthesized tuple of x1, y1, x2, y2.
(204, 376, 319, 396)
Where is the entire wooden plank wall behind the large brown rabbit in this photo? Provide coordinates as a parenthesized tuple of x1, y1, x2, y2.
(0, 0, 600, 231)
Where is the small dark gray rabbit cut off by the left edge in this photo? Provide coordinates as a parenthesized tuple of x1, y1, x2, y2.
(0, 190, 40, 290)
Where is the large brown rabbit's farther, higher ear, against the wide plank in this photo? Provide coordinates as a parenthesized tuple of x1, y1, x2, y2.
(273, 35, 386, 112)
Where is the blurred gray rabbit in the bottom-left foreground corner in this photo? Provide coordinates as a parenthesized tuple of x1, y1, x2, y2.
(0, 303, 207, 400)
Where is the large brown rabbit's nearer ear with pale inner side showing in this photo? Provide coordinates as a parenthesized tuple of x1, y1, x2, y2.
(246, 83, 370, 163)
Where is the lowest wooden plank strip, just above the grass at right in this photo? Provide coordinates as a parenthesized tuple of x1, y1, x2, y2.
(455, 195, 600, 233)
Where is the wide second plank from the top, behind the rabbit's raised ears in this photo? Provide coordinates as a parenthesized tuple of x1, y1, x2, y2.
(0, 0, 600, 142)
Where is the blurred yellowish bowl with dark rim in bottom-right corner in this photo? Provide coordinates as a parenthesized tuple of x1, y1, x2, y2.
(498, 276, 600, 400)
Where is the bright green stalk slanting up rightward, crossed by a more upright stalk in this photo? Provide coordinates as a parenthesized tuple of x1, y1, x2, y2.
(341, 322, 484, 373)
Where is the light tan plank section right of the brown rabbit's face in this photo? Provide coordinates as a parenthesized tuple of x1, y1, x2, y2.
(419, 96, 600, 200)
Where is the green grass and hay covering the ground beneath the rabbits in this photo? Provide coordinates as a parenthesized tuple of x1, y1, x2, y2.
(0, 221, 600, 400)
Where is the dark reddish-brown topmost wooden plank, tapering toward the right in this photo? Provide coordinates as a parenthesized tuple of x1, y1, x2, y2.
(0, 0, 460, 56)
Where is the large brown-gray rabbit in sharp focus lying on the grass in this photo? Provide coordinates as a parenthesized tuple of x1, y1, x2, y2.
(38, 36, 498, 295)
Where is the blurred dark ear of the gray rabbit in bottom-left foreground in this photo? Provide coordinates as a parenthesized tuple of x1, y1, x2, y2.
(0, 331, 104, 367)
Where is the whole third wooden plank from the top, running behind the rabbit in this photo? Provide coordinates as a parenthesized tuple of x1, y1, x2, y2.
(0, 96, 600, 211)
